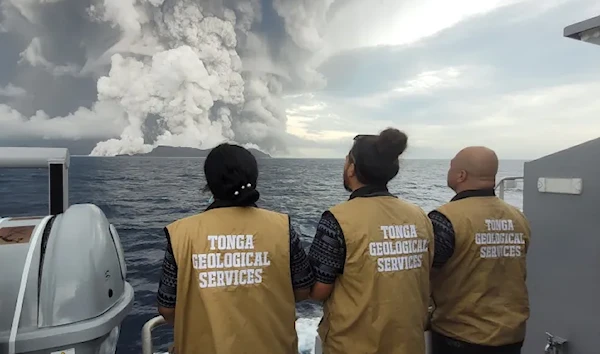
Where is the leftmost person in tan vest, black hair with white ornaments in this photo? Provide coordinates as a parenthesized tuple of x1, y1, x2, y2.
(158, 144, 314, 354)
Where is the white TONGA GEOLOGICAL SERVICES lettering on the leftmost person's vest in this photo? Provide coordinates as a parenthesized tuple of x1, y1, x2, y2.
(192, 235, 271, 289)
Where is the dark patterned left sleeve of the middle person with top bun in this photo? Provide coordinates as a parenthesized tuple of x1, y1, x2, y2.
(308, 211, 346, 284)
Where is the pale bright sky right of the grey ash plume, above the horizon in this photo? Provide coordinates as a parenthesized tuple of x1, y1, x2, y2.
(278, 1, 600, 158)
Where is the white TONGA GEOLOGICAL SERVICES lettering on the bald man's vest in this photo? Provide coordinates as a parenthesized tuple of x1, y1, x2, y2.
(475, 219, 525, 258)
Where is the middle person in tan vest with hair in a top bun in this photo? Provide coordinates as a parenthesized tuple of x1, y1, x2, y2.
(308, 128, 434, 354)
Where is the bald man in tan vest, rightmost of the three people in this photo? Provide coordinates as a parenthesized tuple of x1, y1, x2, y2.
(429, 146, 530, 354)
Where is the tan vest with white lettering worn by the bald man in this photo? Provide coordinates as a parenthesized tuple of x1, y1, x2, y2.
(431, 197, 530, 346)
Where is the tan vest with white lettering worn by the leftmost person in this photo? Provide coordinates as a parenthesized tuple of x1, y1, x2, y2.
(167, 207, 298, 354)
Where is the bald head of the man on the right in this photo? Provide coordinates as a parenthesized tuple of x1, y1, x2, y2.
(448, 146, 498, 191)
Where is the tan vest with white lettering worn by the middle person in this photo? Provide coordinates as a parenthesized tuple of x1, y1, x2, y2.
(319, 196, 433, 354)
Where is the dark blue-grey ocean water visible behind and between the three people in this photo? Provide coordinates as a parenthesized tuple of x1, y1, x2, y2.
(0, 157, 523, 354)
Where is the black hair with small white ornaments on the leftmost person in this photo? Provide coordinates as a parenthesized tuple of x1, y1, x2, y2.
(204, 143, 260, 206)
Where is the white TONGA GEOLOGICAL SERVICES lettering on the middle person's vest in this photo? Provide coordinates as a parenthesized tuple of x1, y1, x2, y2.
(369, 224, 429, 272)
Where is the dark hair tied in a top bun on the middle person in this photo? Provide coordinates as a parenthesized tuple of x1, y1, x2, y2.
(349, 128, 408, 186)
